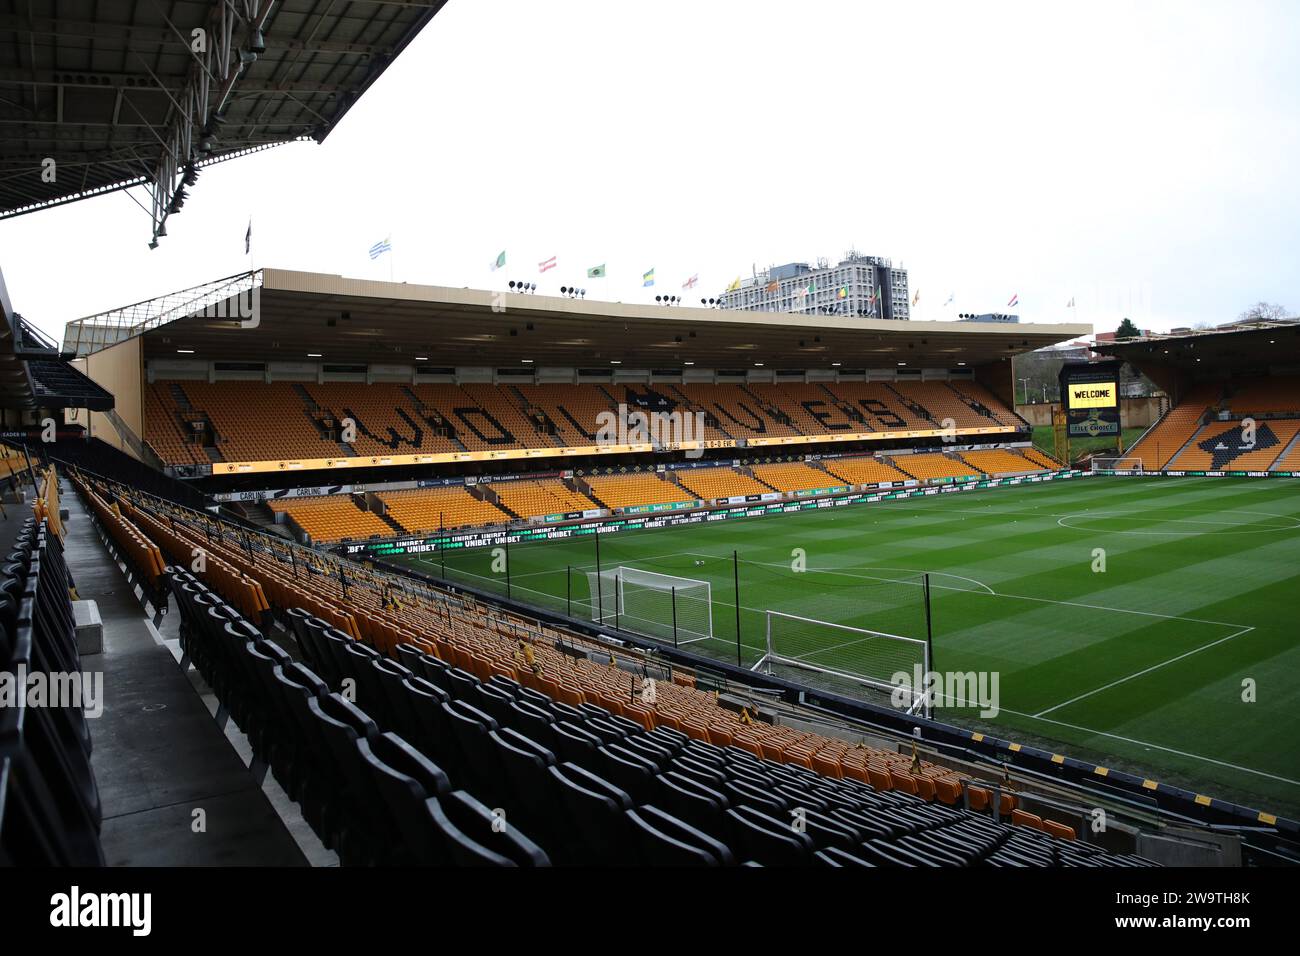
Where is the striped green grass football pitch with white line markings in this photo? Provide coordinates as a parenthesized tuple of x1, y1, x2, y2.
(384, 477, 1300, 816)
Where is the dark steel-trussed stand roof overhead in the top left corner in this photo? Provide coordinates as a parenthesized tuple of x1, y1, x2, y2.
(0, 0, 446, 245)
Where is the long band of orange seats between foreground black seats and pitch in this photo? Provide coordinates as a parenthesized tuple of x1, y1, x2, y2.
(89, 476, 977, 796)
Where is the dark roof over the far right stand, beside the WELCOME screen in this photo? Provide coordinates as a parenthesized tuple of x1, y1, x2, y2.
(1093, 319, 1300, 372)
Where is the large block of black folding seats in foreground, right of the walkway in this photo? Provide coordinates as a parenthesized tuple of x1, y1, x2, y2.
(149, 571, 1159, 866)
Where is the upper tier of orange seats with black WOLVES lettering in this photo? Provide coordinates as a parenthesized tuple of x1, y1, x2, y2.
(144, 380, 1024, 466)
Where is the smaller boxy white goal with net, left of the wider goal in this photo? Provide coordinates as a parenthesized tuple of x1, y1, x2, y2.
(586, 566, 714, 644)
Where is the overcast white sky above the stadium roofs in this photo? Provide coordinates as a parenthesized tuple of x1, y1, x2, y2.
(0, 0, 1300, 338)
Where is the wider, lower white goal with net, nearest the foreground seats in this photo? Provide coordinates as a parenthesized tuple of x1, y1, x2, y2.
(754, 610, 930, 717)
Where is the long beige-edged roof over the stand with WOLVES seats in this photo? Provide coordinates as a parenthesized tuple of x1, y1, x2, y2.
(64, 268, 1091, 371)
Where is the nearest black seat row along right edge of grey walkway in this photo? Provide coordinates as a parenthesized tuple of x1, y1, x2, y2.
(170, 567, 549, 865)
